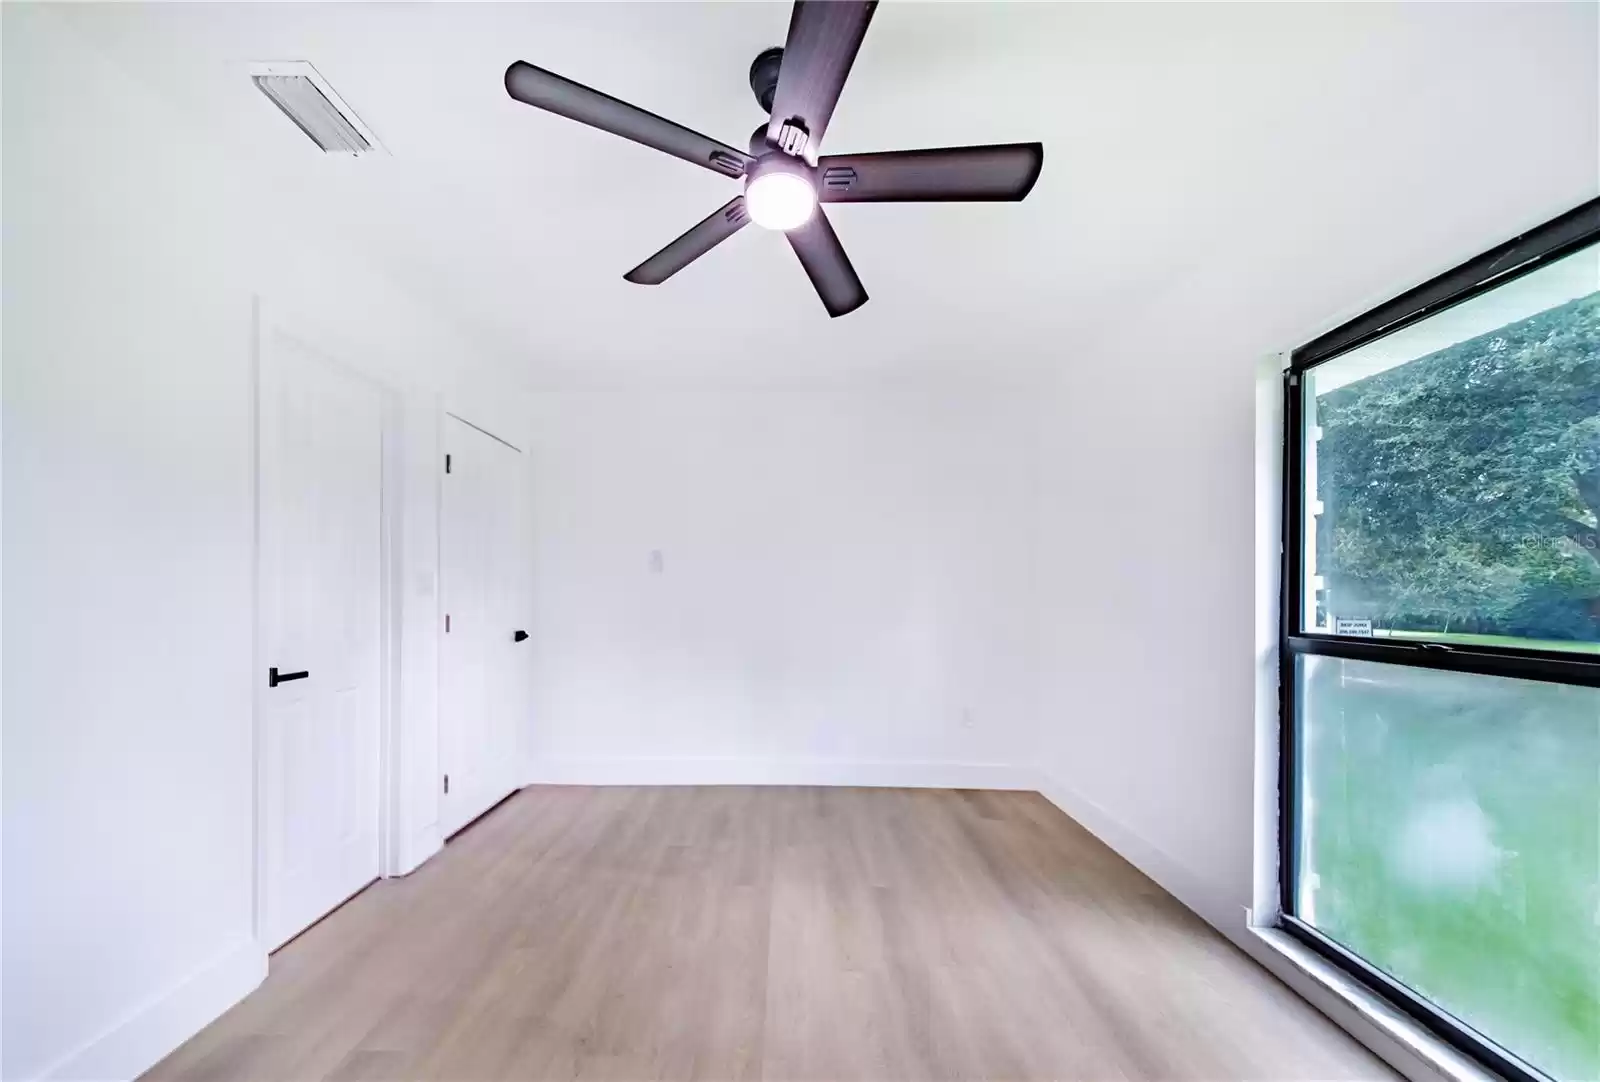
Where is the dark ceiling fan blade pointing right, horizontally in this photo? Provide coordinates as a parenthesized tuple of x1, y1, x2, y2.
(816, 142, 1045, 203)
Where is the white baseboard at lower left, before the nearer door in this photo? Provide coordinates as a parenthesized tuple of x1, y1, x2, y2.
(38, 940, 267, 1082)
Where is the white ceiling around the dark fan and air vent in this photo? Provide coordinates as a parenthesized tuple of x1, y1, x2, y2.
(53, 3, 1600, 386)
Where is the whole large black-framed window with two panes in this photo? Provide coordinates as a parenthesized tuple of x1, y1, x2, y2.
(1280, 200, 1600, 1079)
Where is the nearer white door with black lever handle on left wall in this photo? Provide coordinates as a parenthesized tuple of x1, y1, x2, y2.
(258, 331, 382, 949)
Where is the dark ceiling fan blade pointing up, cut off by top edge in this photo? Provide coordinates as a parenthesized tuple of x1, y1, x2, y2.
(766, 0, 878, 160)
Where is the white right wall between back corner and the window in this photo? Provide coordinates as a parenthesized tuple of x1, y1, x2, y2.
(1037, 307, 1286, 932)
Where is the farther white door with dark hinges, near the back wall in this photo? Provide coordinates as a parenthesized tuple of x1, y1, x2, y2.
(438, 415, 526, 837)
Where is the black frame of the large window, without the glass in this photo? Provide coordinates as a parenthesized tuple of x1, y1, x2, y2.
(1277, 198, 1600, 1082)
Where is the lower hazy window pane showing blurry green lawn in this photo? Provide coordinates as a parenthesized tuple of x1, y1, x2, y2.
(1294, 656, 1600, 1079)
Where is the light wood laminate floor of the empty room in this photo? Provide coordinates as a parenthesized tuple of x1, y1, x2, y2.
(146, 787, 1394, 1080)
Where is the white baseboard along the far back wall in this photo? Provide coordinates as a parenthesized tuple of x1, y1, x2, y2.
(528, 757, 1038, 789)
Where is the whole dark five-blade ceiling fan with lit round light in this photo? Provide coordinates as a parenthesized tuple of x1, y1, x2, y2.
(506, 0, 1045, 315)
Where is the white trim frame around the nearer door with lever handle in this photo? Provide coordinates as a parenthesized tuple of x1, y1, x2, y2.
(250, 295, 405, 949)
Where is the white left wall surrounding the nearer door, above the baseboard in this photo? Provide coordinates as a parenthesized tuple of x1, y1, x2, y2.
(0, 5, 512, 1079)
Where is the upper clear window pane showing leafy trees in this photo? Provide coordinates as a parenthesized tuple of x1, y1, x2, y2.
(1302, 246, 1600, 653)
